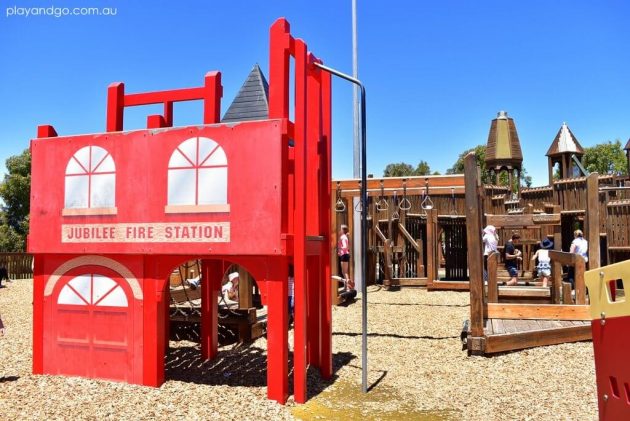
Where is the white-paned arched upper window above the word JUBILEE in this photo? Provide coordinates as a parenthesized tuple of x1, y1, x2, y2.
(63, 146, 116, 215)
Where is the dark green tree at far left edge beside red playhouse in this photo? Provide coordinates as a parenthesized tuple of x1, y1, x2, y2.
(0, 149, 31, 252)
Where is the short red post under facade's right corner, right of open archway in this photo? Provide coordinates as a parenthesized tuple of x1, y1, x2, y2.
(265, 258, 289, 404)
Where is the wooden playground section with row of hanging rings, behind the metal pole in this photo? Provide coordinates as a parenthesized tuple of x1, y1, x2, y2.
(330, 174, 468, 289)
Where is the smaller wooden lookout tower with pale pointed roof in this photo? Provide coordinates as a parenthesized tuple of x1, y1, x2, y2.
(547, 123, 584, 185)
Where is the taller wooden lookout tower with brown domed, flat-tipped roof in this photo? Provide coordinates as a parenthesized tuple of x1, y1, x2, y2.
(485, 111, 523, 192)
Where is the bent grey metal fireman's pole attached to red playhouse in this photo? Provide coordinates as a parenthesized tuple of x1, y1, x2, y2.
(314, 62, 367, 393)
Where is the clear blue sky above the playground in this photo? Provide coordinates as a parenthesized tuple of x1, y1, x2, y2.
(0, 0, 630, 185)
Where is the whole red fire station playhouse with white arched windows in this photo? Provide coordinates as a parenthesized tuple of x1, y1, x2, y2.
(28, 19, 332, 402)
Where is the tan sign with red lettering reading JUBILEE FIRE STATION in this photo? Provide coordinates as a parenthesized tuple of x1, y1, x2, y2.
(61, 222, 230, 243)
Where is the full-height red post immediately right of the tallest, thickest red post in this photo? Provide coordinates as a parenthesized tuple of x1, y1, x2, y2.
(293, 39, 307, 403)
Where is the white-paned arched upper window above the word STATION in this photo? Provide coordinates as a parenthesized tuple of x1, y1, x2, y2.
(166, 137, 230, 212)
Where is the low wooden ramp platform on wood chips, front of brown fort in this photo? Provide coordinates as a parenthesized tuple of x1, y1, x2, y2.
(467, 319, 592, 355)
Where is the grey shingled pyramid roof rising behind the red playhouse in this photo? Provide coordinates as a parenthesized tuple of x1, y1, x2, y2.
(221, 64, 269, 123)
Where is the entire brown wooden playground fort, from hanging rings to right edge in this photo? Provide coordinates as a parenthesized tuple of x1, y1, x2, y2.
(330, 120, 630, 354)
